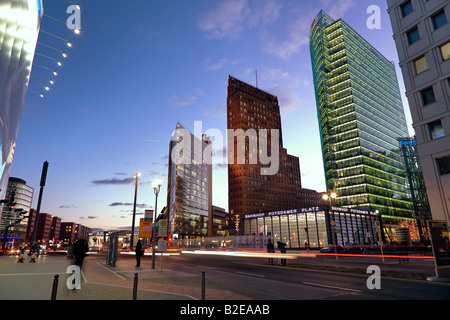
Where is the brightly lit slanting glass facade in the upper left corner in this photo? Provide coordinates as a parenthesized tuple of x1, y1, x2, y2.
(0, 0, 43, 199)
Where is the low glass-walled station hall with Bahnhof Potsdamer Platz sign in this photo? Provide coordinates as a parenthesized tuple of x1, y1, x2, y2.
(241, 206, 383, 249)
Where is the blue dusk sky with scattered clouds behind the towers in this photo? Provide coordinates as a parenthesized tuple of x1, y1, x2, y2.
(10, 0, 413, 230)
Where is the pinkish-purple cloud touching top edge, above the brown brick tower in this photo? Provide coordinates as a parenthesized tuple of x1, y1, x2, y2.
(197, 0, 281, 40)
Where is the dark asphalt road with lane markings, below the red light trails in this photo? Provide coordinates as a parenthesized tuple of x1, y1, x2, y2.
(163, 254, 450, 300)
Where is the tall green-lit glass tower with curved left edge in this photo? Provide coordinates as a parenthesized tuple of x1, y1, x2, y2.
(310, 11, 412, 217)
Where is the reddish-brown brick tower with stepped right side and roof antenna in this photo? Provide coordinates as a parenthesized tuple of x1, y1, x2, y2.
(227, 76, 320, 230)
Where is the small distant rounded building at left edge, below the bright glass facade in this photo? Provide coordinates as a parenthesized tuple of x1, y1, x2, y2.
(0, 177, 34, 247)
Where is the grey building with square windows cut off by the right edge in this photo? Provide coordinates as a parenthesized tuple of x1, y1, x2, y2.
(387, 0, 450, 225)
